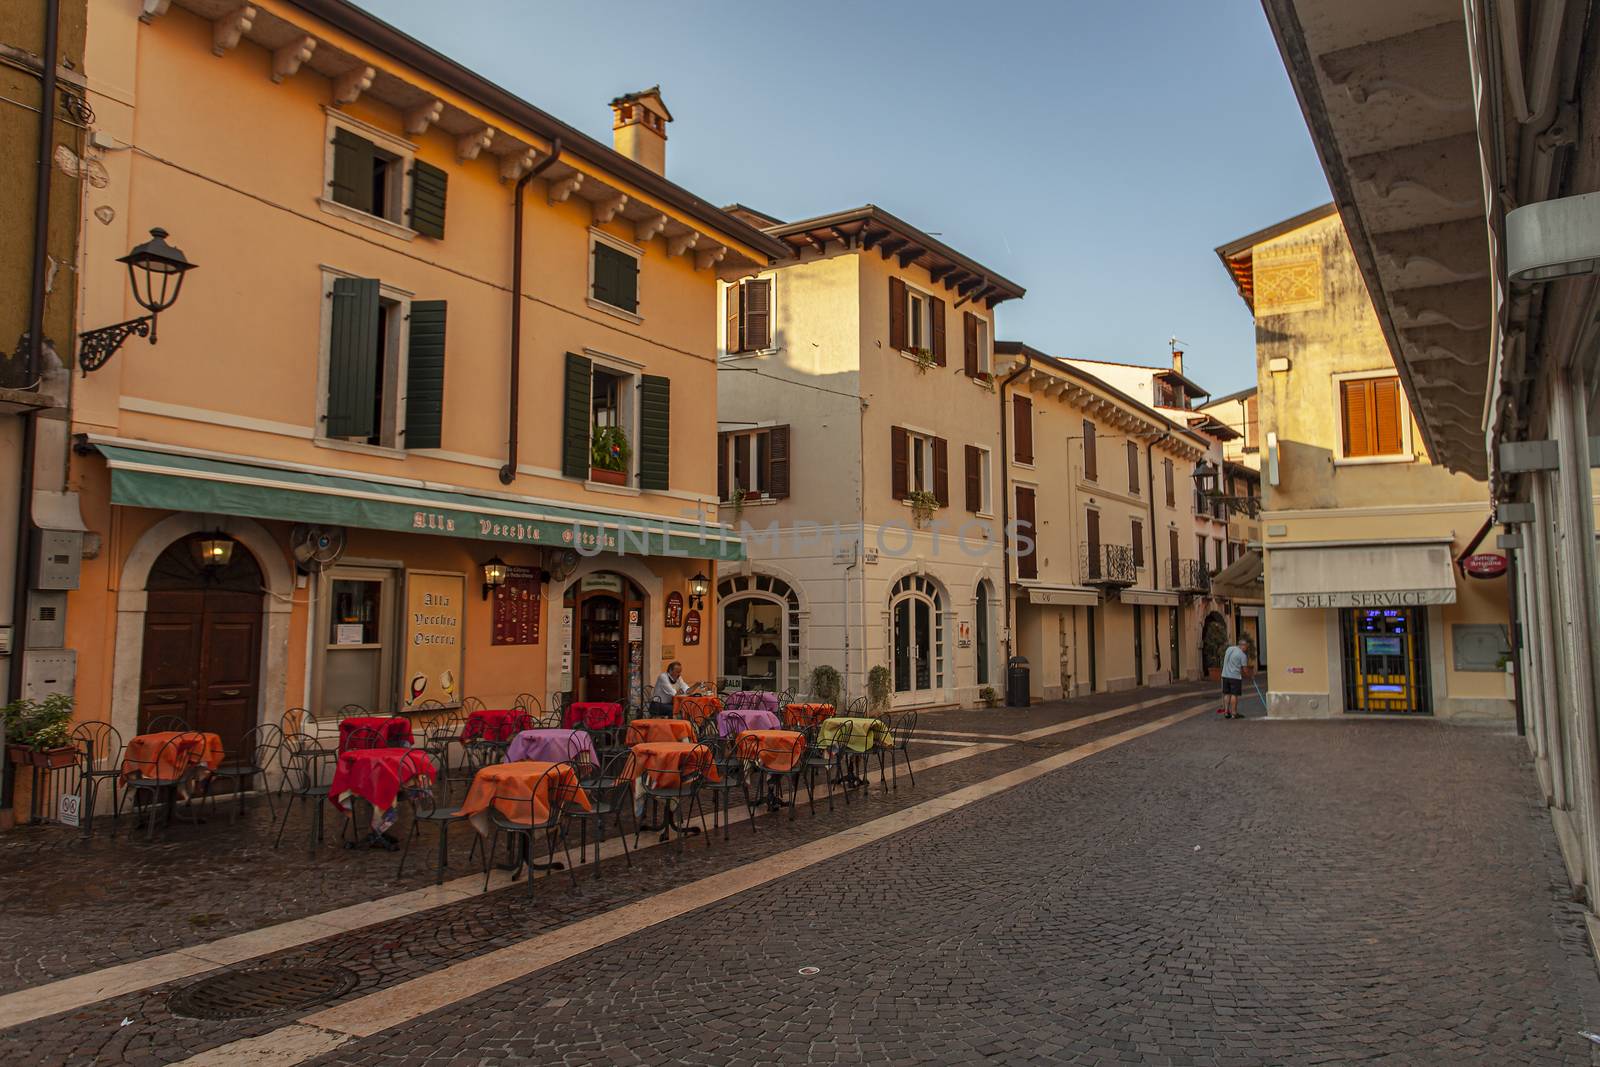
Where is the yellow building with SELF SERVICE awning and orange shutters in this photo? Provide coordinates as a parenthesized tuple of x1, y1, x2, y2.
(1218, 205, 1514, 721)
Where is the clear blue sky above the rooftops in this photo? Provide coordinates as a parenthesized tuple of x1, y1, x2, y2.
(363, 0, 1330, 395)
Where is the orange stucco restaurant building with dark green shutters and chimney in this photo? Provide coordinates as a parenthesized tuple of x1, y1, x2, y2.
(66, 0, 786, 767)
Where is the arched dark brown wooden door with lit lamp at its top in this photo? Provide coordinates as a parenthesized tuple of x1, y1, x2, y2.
(138, 533, 264, 752)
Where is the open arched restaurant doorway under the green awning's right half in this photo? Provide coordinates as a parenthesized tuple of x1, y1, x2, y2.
(563, 571, 648, 702)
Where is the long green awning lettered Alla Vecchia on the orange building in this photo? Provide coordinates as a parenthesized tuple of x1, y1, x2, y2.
(94, 442, 744, 560)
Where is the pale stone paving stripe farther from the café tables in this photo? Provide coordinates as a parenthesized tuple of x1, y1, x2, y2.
(176, 701, 1213, 1067)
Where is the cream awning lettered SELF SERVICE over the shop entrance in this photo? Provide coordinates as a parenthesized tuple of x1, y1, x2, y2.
(1267, 537, 1456, 608)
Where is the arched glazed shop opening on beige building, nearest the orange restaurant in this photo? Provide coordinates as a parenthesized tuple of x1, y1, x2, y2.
(717, 574, 800, 693)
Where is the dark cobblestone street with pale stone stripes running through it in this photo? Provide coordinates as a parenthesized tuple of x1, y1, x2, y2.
(0, 688, 1600, 1067)
